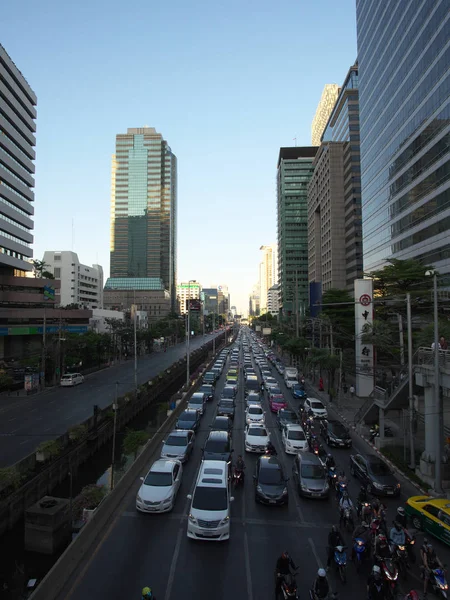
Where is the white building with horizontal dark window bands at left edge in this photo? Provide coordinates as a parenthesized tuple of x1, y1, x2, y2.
(0, 44, 37, 274)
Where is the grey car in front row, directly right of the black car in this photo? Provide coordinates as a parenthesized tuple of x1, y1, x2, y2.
(292, 452, 330, 499)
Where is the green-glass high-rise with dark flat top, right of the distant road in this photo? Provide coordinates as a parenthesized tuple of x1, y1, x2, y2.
(277, 146, 317, 317)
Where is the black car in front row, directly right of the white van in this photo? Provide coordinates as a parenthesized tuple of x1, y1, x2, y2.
(253, 455, 289, 505)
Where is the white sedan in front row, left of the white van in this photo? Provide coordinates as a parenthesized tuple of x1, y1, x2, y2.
(136, 458, 183, 513)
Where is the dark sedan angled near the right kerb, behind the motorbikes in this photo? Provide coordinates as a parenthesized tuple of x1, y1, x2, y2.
(350, 454, 401, 496)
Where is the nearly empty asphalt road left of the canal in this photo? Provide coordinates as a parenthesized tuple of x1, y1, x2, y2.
(0, 334, 223, 468)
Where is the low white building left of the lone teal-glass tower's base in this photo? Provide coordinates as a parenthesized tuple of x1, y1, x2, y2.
(43, 250, 103, 308)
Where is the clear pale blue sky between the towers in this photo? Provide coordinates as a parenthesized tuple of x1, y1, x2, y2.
(0, 0, 356, 312)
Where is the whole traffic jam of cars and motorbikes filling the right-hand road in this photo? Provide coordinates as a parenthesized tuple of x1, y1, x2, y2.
(65, 328, 448, 600)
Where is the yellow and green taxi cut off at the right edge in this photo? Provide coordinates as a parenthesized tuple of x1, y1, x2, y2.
(405, 496, 450, 545)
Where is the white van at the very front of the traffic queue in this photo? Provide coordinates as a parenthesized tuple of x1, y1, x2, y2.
(187, 460, 234, 542)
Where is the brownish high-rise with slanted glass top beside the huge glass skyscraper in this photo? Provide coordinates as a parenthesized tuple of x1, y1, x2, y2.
(308, 65, 363, 292)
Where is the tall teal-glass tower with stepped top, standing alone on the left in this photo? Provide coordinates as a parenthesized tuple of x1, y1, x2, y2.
(111, 127, 177, 310)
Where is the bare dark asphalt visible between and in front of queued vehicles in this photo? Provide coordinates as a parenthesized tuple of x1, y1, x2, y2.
(60, 332, 450, 600)
